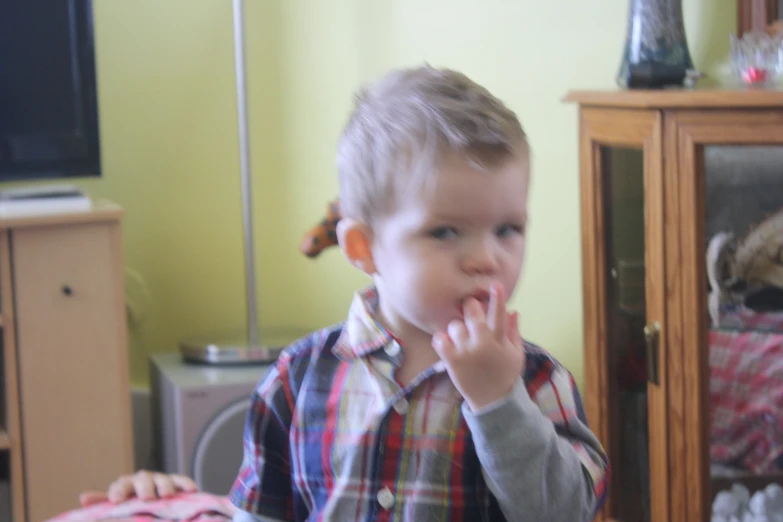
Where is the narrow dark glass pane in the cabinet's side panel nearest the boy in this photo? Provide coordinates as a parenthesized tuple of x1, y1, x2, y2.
(601, 147, 650, 522)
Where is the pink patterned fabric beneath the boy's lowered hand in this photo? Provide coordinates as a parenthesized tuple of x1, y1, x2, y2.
(46, 493, 235, 522)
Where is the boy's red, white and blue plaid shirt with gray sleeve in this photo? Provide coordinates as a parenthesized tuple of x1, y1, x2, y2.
(230, 288, 608, 522)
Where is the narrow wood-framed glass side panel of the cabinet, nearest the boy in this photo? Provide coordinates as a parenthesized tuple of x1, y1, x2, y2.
(580, 108, 668, 522)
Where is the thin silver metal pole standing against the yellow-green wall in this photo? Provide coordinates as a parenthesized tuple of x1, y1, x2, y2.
(234, 0, 258, 347)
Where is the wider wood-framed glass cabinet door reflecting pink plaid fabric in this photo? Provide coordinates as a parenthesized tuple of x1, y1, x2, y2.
(672, 111, 783, 520)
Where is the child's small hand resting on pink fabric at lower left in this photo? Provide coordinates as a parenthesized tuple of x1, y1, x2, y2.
(79, 470, 198, 507)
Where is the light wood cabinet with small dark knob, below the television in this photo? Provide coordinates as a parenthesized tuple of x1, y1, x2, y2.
(0, 206, 133, 522)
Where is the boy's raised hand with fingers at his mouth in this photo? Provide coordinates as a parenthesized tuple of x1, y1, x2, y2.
(432, 280, 525, 410)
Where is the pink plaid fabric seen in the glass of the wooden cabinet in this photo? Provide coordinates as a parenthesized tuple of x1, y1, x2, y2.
(709, 309, 783, 473)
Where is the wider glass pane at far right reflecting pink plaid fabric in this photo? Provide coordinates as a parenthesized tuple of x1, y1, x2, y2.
(704, 146, 783, 506)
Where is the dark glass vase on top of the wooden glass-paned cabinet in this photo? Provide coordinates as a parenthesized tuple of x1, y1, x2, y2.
(617, 0, 693, 89)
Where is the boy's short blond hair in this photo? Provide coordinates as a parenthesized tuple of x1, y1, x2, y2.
(337, 65, 527, 224)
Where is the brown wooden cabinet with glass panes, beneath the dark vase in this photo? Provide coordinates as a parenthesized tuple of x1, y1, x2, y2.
(568, 90, 783, 522)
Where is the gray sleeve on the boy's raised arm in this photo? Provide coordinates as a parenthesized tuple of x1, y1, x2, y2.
(463, 379, 606, 522)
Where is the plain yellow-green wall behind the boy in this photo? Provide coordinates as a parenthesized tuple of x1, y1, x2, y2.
(26, 0, 736, 384)
